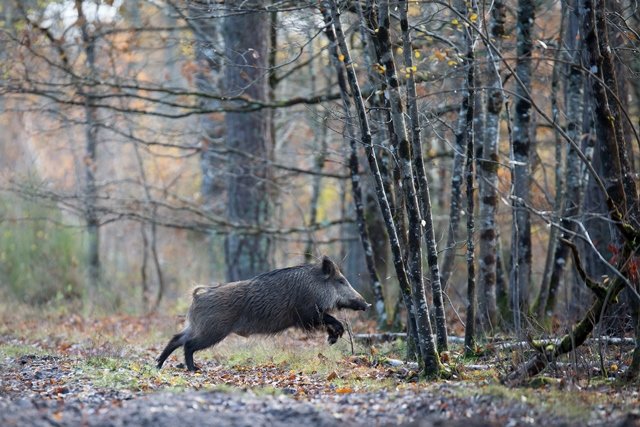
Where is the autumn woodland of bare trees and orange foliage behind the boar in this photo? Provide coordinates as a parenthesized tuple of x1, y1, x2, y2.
(0, 0, 640, 378)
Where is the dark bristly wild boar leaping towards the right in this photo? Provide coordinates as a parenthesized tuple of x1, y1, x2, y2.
(156, 257, 370, 371)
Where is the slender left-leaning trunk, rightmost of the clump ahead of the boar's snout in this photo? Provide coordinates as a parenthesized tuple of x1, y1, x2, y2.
(399, 0, 448, 352)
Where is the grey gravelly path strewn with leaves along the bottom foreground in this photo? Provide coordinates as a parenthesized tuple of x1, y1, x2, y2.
(0, 355, 640, 427)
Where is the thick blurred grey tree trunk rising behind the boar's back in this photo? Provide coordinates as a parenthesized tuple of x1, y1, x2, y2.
(223, 1, 274, 281)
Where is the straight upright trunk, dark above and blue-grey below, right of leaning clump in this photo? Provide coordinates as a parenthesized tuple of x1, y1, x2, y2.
(509, 0, 535, 332)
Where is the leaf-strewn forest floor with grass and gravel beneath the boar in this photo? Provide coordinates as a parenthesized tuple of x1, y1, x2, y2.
(0, 310, 640, 427)
